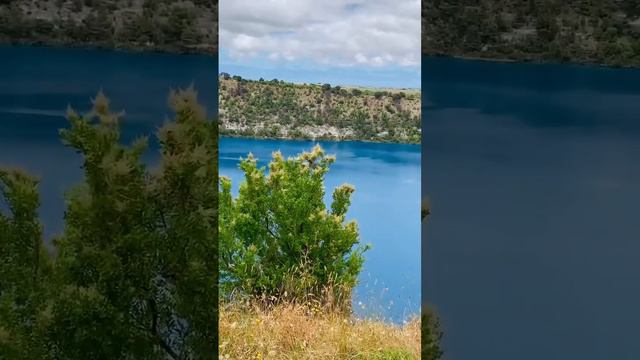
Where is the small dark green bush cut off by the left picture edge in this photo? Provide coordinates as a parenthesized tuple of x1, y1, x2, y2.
(0, 169, 50, 360)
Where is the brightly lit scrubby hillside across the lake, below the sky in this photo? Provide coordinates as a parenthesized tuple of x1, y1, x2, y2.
(219, 73, 421, 143)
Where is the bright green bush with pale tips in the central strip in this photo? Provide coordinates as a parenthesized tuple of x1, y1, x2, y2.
(220, 146, 367, 308)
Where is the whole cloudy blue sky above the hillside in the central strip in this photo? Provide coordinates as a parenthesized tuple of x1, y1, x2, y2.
(219, 0, 421, 88)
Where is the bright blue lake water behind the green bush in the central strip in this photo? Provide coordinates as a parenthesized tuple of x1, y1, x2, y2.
(220, 138, 421, 322)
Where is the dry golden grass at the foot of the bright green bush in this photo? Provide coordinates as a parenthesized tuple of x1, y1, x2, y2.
(219, 305, 420, 360)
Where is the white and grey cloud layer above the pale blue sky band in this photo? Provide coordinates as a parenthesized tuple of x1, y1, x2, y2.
(219, 0, 421, 67)
